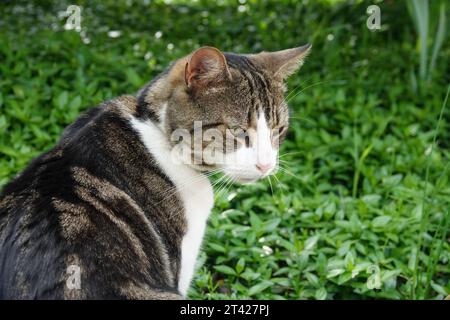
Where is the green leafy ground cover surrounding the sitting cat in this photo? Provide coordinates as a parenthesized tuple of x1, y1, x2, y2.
(0, 0, 450, 299)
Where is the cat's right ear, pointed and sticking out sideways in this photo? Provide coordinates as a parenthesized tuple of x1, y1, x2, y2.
(253, 44, 312, 80)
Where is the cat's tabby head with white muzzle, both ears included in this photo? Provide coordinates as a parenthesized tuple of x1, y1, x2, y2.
(139, 45, 311, 182)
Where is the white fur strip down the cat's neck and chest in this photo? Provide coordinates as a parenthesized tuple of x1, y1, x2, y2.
(127, 117, 214, 296)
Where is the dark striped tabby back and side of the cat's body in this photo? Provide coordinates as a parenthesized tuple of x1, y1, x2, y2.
(0, 96, 182, 299)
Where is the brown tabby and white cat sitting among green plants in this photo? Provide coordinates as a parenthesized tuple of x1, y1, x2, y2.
(0, 45, 311, 299)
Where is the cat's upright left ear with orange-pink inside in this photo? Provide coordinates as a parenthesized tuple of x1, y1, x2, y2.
(184, 47, 231, 88)
